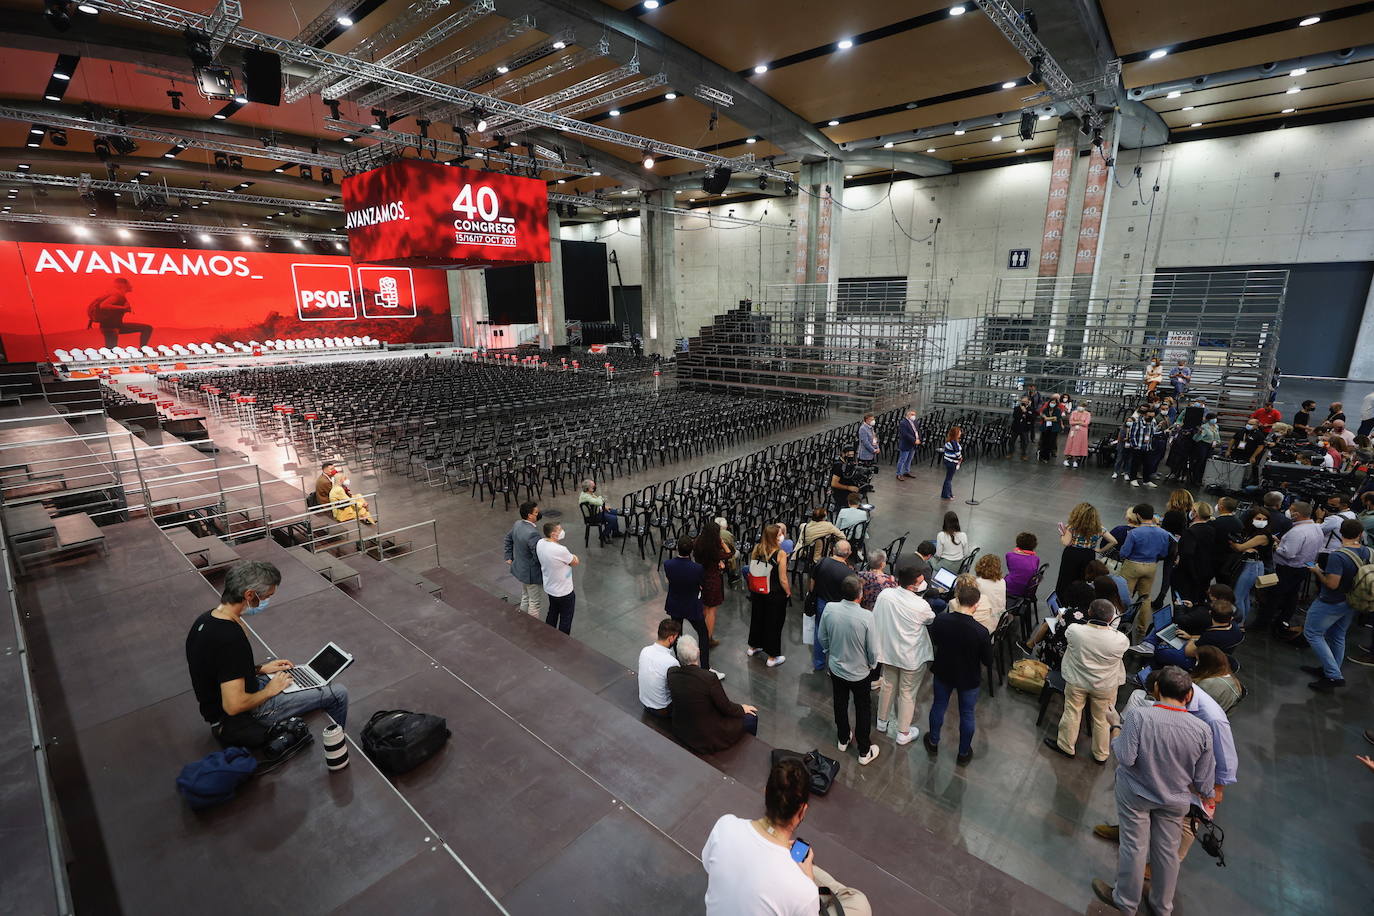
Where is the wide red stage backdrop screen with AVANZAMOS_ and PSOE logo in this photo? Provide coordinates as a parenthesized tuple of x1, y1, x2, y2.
(0, 242, 453, 361)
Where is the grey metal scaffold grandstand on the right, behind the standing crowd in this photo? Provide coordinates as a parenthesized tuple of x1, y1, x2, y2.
(934, 271, 1287, 420)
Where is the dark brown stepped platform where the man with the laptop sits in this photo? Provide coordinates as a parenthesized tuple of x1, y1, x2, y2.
(10, 520, 1066, 913)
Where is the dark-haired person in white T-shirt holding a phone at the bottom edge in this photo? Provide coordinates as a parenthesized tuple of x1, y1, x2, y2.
(701, 758, 872, 916)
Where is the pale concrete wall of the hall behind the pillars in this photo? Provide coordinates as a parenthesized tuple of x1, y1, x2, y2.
(552, 119, 1374, 369)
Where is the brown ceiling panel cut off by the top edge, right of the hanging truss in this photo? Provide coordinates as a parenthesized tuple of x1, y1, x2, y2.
(1099, 0, 1326, 55)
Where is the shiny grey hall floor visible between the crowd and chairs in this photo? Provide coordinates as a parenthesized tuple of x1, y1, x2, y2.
(203, 398, 1374, 913)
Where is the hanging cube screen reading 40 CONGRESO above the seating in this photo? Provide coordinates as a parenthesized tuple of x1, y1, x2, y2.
(344, 159, 548, 268)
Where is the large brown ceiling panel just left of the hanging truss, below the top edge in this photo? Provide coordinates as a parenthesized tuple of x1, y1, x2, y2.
(752, 14, 1029, 121)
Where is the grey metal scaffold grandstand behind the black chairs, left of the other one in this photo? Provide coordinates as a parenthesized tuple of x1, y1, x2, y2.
(677, 280, 948, 409)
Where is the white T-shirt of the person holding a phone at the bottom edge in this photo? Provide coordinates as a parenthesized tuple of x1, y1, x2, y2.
(701, 814, 820, 916)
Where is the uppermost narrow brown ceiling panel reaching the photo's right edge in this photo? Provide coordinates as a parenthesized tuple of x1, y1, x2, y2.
(1121, 15, 1374, 88)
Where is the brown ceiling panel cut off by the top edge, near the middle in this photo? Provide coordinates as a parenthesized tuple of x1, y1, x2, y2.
(640, 0, 950, 70)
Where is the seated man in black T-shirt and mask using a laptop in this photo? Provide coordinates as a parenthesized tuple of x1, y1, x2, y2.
(185, 560, 353, 746)
